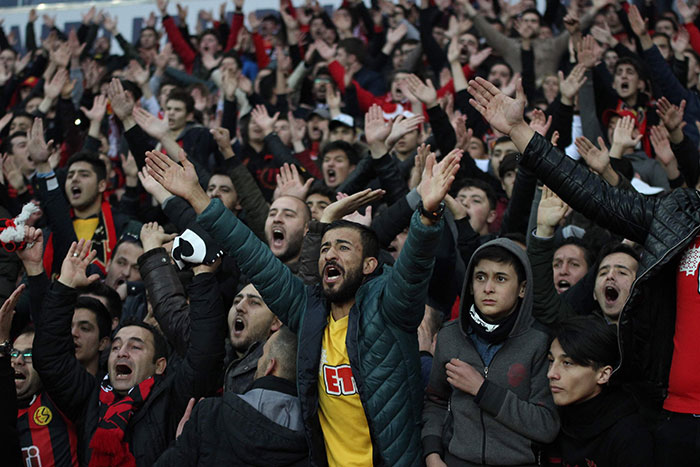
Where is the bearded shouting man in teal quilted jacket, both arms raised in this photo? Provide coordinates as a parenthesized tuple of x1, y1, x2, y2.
(148, 145, 461, 466)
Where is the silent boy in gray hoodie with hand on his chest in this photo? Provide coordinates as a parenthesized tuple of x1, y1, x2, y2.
(422, 238, 559, 467)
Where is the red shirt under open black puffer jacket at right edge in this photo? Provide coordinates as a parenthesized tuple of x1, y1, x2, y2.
(664, 235, 700, 414)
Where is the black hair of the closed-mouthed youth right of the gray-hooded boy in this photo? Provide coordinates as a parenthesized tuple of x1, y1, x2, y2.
(554, 315, 620, 370)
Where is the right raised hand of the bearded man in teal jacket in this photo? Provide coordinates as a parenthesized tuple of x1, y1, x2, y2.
(418, 149, 464, 214)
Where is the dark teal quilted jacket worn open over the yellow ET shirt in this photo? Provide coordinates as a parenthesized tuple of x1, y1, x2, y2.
(197, 200, 443, 466)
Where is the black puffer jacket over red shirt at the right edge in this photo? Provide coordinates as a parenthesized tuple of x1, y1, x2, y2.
(520, 134, 700, 406)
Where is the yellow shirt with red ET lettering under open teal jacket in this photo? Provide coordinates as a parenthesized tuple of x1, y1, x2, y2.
(318, 315, 372, 467)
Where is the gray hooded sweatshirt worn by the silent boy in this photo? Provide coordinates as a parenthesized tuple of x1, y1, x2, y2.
(422, 238, 559, 466)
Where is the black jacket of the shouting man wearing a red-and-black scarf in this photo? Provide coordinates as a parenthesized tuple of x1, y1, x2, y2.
(33, 274, 226, 467)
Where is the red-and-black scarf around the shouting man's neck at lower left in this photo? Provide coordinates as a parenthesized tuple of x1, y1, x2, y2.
(90, 376, 155, 467)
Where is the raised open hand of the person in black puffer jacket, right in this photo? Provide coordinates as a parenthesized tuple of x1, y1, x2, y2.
(468, 78, 526, 135)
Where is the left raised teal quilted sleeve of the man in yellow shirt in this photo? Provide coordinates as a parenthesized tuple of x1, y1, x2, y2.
(197, 199, 306, 334)
